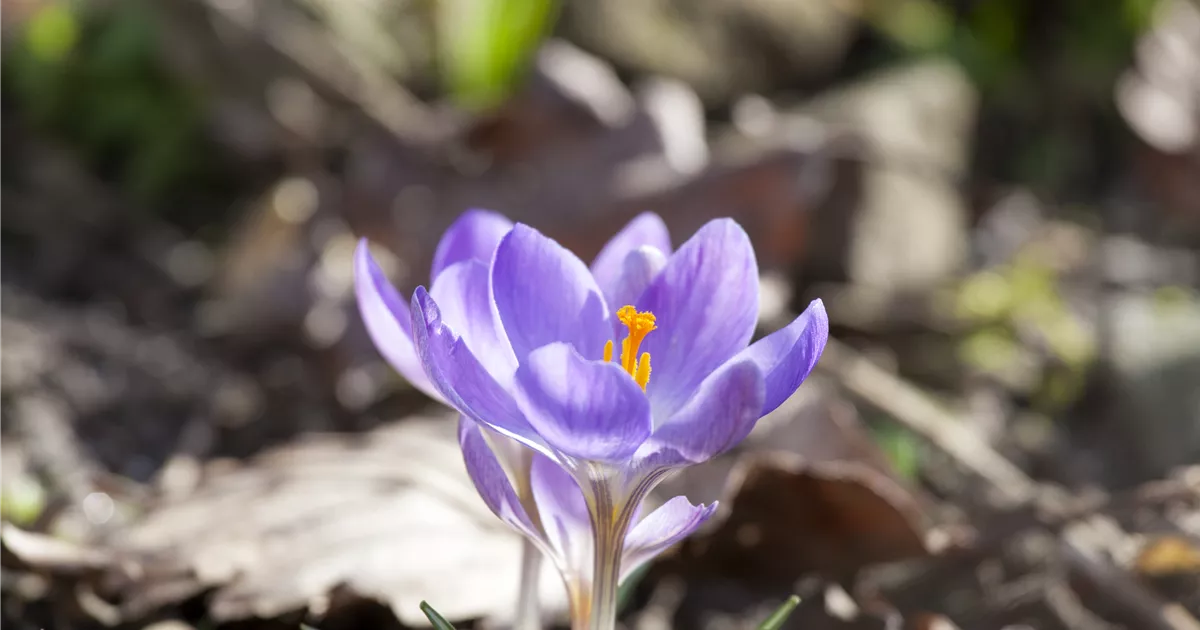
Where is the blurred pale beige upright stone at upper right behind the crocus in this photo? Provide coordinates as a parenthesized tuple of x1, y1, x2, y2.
(784, 61, 978, 293)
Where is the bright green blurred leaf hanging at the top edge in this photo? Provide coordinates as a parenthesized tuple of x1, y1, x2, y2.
(438, 0, 558, 109)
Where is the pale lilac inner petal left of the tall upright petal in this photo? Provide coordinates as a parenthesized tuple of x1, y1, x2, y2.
(430, 259, 517, 384)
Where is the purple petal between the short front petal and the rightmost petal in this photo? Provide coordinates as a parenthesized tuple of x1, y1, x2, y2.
(643, 360, 766, 463)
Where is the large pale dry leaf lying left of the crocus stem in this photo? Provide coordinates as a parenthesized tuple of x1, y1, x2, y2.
(4, 416, 565, 625)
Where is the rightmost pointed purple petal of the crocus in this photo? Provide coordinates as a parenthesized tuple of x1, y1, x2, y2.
(738, 300, 829, 415)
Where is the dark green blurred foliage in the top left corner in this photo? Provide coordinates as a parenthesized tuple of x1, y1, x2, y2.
(0, 0, 213, 203)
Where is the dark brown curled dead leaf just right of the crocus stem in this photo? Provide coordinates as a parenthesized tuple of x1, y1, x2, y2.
(658, 391, 930, 629)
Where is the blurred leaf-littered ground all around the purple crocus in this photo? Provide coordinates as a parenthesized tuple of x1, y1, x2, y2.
(0, 0, 1200, 630)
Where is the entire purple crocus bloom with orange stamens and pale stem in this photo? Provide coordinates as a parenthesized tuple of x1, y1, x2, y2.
(358, 214, 828, 628)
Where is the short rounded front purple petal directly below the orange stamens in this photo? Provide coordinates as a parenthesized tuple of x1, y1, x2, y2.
(515, 343, 650, 462)
